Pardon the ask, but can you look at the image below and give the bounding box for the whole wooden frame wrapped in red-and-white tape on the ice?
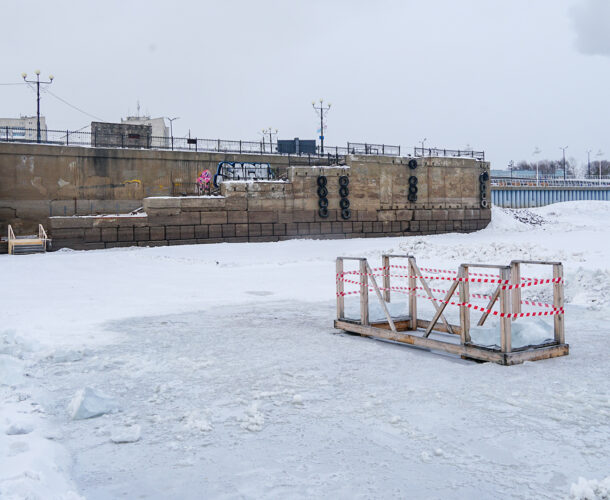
[334,255,569,365]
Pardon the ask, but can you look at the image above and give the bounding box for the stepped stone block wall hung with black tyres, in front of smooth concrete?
[49,157,491,249]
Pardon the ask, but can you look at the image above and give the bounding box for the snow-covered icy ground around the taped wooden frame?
[0,202,610,499]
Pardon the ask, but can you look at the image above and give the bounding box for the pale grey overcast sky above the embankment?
[0,0,610,168]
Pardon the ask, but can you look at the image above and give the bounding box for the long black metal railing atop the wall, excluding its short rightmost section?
[0,127,400,157]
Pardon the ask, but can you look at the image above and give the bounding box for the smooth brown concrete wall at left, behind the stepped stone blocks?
[0,142,308,234]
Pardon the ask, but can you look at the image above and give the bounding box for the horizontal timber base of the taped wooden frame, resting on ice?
[335,318,569,365]
